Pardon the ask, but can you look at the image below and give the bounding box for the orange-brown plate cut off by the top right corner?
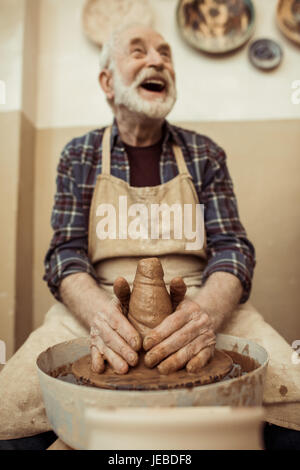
[276,0,300,45]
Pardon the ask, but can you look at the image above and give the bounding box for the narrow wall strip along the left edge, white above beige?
[0,0,25,358]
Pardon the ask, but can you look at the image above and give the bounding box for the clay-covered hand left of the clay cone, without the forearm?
[90,278,142,374]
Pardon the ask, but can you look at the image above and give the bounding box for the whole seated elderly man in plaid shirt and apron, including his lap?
[0,25,300,450]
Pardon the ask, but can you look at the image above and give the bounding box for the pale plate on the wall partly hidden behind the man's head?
[82,0,154,47]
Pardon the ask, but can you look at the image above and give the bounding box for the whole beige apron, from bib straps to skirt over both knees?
[0,126,300,439]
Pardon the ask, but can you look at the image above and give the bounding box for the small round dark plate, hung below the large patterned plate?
[249,39,283,70]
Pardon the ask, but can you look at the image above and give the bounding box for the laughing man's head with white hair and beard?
[108,28,176,121]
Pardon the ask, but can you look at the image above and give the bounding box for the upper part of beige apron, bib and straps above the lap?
[89,123,206,292]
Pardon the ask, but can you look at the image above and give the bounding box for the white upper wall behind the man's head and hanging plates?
[37,0,300,128]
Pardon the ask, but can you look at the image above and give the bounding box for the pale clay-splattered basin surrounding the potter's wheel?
[37,334,268,449]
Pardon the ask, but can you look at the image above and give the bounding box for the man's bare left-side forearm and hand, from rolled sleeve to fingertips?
[60,273,142,374]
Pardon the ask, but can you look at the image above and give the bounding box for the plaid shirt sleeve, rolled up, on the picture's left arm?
[44,144,97,300]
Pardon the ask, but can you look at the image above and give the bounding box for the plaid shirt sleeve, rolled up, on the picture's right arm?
[201,143,255,303]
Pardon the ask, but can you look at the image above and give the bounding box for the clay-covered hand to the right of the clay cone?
[143,297,216,374]
